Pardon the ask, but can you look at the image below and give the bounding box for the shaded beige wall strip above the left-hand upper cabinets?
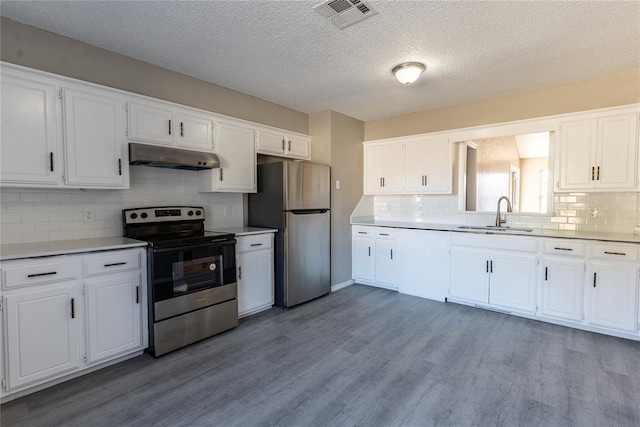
[0,18,309,134]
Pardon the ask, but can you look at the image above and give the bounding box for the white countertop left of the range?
[0,237,147,261]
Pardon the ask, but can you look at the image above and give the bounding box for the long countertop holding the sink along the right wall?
[351,220,640,243]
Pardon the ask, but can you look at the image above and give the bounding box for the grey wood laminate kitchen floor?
[0,285,640,427]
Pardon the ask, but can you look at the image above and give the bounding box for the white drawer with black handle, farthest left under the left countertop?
[2,258,78,289]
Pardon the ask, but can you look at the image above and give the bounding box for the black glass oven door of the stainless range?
[150,240,236,303]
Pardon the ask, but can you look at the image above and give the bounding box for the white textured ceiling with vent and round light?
[0,0,640,120]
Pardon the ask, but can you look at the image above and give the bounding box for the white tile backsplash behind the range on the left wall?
[0,166,243,244]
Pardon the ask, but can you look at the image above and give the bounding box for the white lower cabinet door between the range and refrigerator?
[238,251,273,316]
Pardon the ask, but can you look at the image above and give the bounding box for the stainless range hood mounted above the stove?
[129,142,220,171]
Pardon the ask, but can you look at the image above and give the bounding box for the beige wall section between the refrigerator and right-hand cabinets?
[309,111,364,286]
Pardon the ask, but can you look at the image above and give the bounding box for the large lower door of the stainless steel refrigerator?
[283,210,331,307]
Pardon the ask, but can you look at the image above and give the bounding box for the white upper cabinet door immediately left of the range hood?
[64,89,129,188]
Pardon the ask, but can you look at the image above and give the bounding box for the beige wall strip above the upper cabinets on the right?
[365,71,640,141]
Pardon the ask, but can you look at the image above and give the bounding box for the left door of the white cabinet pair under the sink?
[449,248,489,304]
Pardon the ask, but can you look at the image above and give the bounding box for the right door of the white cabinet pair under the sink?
[489,254,537,313]
